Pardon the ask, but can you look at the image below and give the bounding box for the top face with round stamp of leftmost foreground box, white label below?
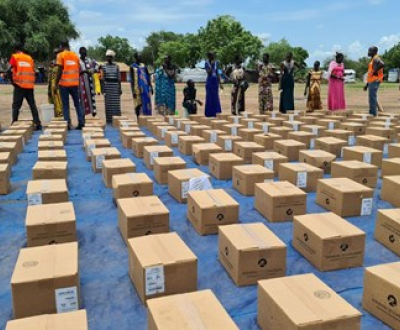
[11,242,78,284]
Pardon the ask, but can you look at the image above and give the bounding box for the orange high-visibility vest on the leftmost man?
[13,53,35,89]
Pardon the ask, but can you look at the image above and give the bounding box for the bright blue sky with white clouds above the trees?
[63,0,400,63]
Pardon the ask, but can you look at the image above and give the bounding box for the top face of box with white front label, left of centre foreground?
[129,232,197,268]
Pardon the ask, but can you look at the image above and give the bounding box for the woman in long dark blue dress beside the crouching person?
[204,52,223,117]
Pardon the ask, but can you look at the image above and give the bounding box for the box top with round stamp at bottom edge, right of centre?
[259,274,361,326]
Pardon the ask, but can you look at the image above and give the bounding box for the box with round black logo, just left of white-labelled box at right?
[254,181,307,222]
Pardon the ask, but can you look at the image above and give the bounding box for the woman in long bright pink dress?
[328,53,346,111]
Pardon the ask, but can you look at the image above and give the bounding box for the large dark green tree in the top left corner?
[0,0,79,61]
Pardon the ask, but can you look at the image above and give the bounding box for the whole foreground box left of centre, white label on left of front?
[128,233,198,304]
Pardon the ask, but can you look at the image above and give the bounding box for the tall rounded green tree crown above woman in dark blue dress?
[199,16,263,65]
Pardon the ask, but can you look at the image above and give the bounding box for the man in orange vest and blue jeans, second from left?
[54,41,85,130]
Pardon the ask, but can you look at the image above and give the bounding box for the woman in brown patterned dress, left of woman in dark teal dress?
[258,53,275,115]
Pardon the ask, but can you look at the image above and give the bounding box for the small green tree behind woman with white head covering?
[88,35,136,65]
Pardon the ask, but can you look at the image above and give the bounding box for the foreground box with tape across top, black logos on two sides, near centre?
[218,223,286,286]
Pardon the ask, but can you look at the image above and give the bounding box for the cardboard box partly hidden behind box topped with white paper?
[168,168,207,203]
